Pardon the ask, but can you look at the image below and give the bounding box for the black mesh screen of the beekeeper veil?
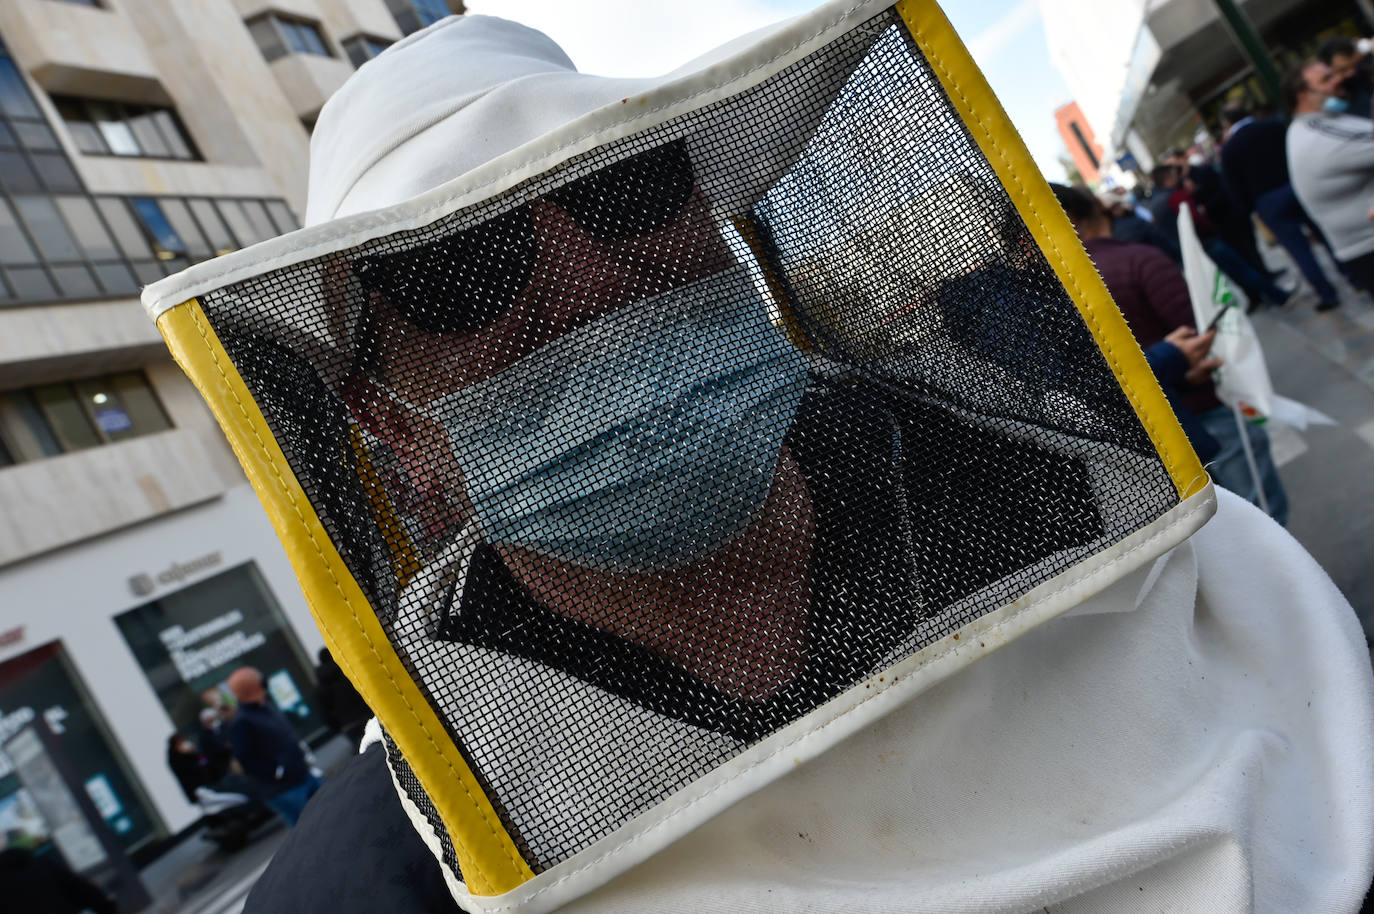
[203,8,1178,871]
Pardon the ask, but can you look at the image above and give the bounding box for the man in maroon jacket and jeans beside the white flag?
[1050,184,1287,524]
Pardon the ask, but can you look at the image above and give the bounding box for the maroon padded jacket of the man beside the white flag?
[1084,238,1221,423]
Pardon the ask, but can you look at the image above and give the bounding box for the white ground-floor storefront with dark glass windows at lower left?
[0,485,326,855]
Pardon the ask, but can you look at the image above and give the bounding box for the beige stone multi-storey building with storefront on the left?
[0,0,462,860]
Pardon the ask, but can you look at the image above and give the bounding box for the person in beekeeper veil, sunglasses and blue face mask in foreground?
[146,0,1374,914]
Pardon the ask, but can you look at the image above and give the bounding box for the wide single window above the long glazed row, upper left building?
[52,96,201,159]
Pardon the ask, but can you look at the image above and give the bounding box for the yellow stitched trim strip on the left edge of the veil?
[158,298,534,895]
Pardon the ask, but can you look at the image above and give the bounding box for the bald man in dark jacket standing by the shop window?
[229,667,322,826]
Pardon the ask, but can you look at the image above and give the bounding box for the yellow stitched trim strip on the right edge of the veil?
[896,0,1208,499]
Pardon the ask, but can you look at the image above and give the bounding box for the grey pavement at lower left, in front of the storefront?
[140,737,354,914]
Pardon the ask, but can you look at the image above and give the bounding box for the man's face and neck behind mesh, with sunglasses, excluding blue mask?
[339,142,812,698]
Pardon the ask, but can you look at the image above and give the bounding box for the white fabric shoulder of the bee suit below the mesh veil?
[563,491,1374,914]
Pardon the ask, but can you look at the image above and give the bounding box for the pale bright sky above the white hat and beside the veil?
[467,0,1069,180]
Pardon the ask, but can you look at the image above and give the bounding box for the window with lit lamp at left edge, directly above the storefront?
[0,371,172,463]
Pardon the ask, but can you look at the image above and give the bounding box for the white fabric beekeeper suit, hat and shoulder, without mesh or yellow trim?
[146,3,1374,914]
